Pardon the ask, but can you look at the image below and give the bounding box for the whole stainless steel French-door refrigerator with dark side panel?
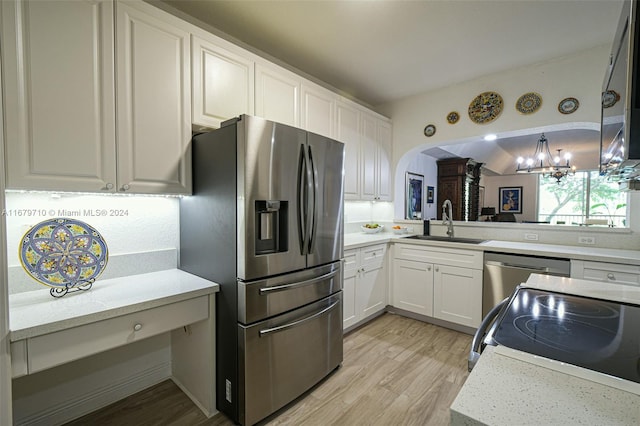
[180,115,344,424]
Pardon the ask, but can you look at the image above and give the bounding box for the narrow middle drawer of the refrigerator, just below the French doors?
[238,262,342,325]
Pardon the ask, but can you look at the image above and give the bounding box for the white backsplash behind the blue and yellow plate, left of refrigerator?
[4,191,179,294]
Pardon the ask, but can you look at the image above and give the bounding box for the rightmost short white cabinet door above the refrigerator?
[300,83,336,138]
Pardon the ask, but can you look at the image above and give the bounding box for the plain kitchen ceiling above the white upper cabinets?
[158,0,622,106]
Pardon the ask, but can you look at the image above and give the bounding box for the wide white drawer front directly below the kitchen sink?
[394,244,483,269]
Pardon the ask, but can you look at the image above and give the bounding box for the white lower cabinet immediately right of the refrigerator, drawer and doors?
[342,244,388,329]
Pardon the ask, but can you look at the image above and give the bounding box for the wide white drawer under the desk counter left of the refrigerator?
[27,296,209,374]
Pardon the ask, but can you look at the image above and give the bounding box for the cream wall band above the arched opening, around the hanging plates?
[379,46,610,164]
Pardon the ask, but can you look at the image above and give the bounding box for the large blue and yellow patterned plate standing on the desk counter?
[19,218,109,288]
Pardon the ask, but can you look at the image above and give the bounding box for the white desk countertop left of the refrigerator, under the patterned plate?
[9,269,219,341]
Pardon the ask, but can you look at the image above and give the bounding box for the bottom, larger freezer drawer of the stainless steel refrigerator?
[238,292,342,425]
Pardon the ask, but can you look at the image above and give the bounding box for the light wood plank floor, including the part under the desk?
[68,314,471,426]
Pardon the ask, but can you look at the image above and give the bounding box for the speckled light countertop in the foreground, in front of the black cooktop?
[450,346,640,426]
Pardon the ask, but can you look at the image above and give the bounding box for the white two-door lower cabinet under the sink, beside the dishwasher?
[392,244,483,327]
